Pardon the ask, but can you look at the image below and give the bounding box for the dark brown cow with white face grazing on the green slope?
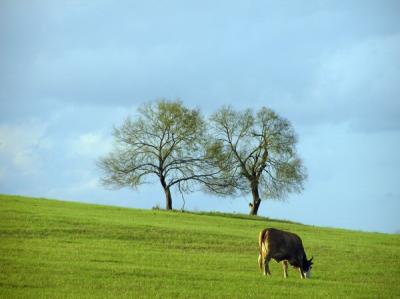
[258,228,313,278]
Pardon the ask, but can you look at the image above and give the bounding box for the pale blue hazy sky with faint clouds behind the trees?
[0,0,400,233]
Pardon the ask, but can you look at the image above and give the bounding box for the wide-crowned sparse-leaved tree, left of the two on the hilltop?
[98,100,222,210]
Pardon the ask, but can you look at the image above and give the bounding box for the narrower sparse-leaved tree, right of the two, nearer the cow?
[211,107,306,215]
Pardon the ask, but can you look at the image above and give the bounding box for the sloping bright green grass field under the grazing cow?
[0,195,400,298]
